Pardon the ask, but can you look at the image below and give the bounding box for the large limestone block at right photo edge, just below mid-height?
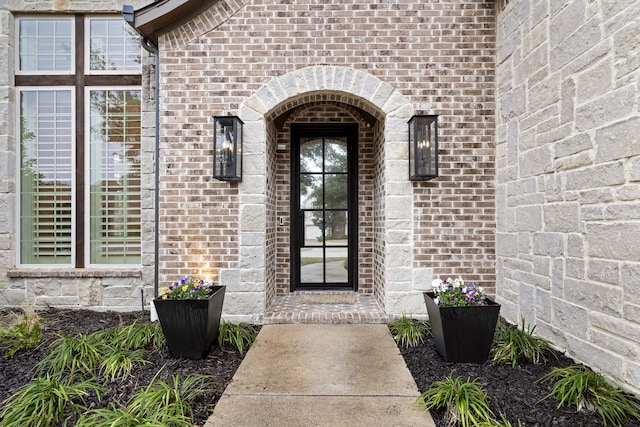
[586,222,640,261]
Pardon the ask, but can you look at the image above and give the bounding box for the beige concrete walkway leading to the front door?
[205,324,434,427]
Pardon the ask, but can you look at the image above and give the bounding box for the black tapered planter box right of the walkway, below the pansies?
[424,292,500,363]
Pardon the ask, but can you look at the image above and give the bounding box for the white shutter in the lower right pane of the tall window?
[89,89,141,264]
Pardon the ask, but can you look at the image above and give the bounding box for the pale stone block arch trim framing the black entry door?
[225,66,424,320]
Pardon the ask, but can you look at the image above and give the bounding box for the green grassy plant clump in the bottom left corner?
[0,375,103,427]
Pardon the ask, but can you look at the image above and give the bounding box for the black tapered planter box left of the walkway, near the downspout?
[153,286,226,359]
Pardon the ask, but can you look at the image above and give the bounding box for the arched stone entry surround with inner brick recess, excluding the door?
[235,66,413,322]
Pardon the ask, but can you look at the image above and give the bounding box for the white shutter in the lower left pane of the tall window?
[20,90,73,264]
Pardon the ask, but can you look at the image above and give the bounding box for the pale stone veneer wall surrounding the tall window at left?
[0,0,155,311]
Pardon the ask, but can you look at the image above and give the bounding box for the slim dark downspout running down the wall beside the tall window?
[122,5,160,300]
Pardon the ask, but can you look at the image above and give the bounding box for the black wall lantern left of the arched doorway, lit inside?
[213,116,244,181]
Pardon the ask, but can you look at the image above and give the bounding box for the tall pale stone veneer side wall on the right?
[496,0,640,393]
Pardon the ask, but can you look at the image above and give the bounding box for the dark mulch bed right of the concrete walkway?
[401,338,640,427]
